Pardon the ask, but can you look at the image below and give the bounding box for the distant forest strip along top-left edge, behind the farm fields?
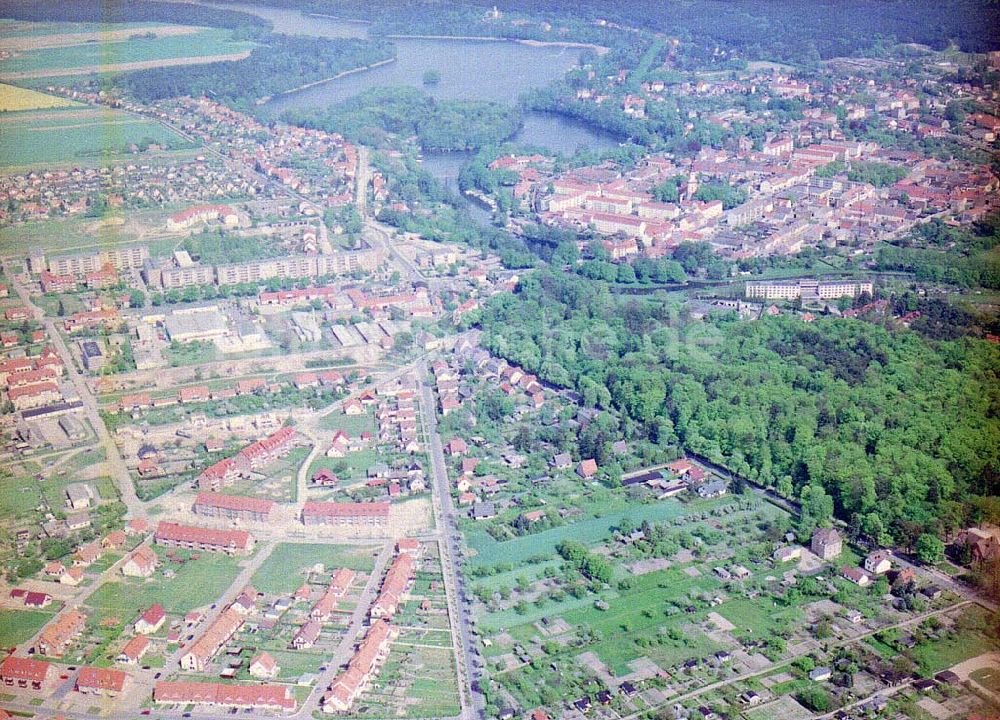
[0,0,271,30]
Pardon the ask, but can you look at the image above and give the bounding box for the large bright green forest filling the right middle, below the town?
[479,271,1000,542]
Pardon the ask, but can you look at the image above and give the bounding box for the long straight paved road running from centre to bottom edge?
[418,364,485,720]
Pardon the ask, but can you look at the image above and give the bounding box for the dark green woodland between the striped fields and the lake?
[124,33,395,109]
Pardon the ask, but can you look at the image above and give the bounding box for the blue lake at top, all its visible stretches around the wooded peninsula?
[205,3,618,221]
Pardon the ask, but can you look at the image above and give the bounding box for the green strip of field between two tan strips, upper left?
[0,29,253,75]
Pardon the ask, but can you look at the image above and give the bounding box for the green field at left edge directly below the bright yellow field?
[0,107,191,167]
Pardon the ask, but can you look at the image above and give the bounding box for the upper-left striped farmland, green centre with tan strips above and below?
[0,27,253,80]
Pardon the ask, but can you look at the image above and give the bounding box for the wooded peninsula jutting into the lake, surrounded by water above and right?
[282,87,521,150]
